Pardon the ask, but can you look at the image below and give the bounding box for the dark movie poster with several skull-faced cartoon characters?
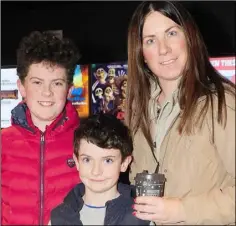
[91,62,127,120]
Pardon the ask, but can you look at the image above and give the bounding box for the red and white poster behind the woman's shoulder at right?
[210,56,235,84]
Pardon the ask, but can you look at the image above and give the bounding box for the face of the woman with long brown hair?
[142,11,187,83]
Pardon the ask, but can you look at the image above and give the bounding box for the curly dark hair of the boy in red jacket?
[17,31,80,84]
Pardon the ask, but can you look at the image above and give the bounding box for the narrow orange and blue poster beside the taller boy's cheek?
[68,65,89,118]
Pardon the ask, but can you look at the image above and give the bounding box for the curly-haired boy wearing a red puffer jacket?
[1,32,80,225]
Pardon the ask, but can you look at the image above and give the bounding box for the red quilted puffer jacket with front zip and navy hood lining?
[1,102,80,225]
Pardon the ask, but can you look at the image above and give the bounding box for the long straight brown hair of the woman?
[126,1,235,150]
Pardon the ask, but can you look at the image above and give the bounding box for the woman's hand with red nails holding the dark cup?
[133,196,186,224]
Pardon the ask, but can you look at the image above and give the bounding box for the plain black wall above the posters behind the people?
[1,1,235,65]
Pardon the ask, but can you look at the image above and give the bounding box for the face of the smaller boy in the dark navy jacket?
[74,139,131,193]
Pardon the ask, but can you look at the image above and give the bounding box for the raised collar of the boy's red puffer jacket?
[11,101,79,134]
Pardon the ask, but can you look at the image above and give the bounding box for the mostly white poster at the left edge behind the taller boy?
[1,68,22,128]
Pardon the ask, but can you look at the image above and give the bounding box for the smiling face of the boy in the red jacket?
[17,63,68,124]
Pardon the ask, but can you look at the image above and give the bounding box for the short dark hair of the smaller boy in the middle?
[74,113,133,161]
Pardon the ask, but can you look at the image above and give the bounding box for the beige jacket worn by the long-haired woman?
[130,89,235,225]
